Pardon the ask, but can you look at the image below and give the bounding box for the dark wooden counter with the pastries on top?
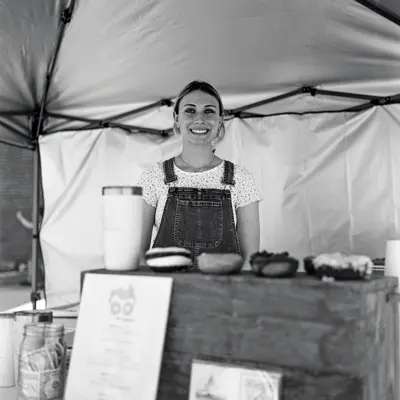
[82,270,399,400]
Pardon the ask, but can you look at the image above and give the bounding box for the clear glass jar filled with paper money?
[17,323,66,400]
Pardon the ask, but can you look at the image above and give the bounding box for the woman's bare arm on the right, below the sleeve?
[236,201,260,269]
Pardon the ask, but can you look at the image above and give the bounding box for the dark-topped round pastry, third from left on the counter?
[250,250,299,278]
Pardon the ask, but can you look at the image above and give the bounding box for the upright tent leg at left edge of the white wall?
[31,143,40,310]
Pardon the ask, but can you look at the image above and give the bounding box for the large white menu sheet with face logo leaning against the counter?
[65,274,172,400]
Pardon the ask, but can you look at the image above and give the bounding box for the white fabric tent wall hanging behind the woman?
[40,105,400,307]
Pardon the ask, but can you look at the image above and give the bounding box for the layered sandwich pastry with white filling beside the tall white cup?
[145,247,192,272]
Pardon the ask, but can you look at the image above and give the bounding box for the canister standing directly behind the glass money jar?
[13,310,53,385]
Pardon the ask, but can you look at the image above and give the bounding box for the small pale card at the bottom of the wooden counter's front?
[189,359,282,400]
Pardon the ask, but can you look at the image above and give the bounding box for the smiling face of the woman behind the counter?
[177,90,222,144]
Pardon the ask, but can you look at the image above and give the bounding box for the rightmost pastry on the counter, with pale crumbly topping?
[312,253,374,280]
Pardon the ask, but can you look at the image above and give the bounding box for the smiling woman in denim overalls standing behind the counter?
[139,81,261,268]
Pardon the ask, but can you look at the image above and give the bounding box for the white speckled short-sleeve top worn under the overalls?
[138,158,262,230]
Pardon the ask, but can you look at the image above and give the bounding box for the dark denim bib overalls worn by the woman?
[153,159,240,266]
